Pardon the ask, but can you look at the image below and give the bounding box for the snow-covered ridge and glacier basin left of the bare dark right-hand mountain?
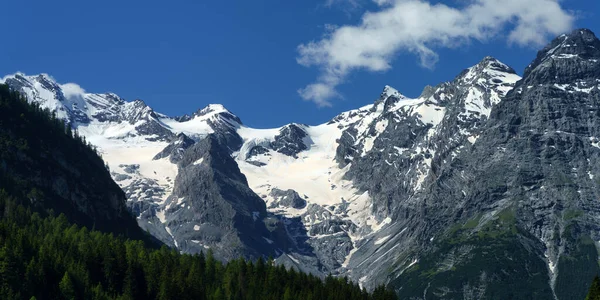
[3,57,519,276]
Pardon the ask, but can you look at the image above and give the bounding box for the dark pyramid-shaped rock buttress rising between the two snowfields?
[159,135,276,259]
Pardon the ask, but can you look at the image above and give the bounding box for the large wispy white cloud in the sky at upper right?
[297,0,574,105]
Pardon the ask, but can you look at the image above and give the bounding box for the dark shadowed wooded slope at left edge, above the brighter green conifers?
[0,85,146,238]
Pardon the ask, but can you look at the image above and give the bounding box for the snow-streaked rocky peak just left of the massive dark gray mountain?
[336,57,520,219]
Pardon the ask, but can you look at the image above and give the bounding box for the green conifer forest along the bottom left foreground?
[0,190,395,300]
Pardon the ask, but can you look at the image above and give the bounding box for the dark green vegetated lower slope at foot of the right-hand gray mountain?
[390,209,553,299]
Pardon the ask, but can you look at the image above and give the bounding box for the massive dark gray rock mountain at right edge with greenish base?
[378,30,600,299]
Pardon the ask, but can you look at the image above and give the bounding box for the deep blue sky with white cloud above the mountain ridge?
[0,0,600,127]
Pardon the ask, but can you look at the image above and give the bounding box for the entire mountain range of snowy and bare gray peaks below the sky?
[0,29,600,300]
